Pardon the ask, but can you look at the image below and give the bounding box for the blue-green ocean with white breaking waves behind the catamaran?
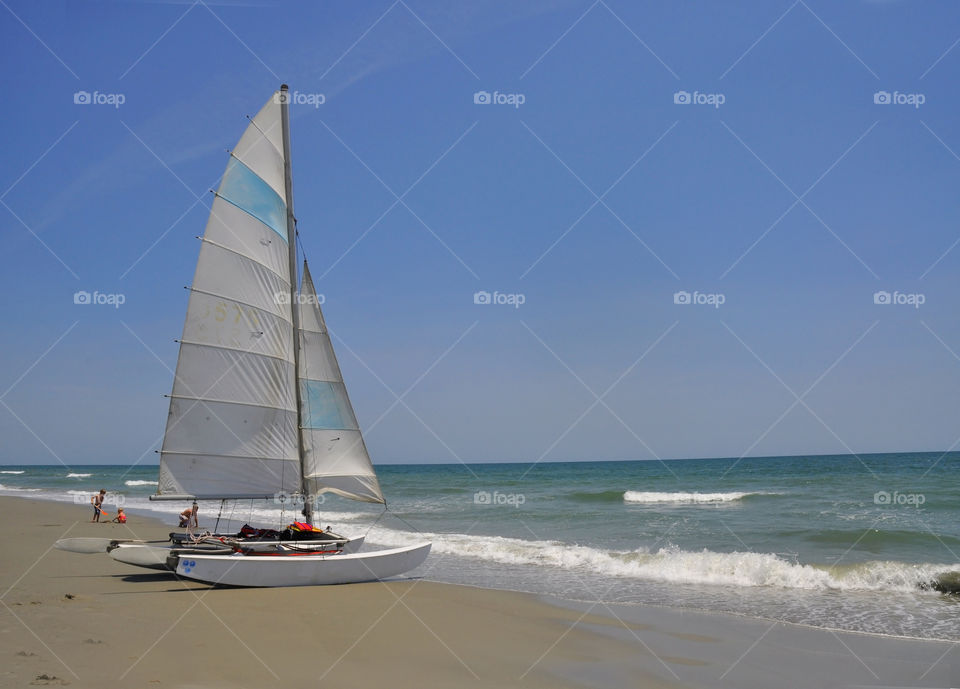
[0,453,960,640]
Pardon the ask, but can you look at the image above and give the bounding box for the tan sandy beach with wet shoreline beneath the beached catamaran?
[0,497,960,688]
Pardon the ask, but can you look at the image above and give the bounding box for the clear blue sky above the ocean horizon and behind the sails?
[0,0,960,464]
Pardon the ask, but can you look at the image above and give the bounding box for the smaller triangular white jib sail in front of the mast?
[297,262,384,503]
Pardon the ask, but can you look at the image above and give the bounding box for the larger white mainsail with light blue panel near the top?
[158,94,301,498]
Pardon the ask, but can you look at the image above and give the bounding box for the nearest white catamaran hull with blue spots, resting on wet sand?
[176,543,431,587]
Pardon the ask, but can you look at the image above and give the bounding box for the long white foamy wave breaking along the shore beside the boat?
[368,527,960,591]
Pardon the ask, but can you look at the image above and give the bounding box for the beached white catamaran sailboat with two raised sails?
[60,84,431,586]
